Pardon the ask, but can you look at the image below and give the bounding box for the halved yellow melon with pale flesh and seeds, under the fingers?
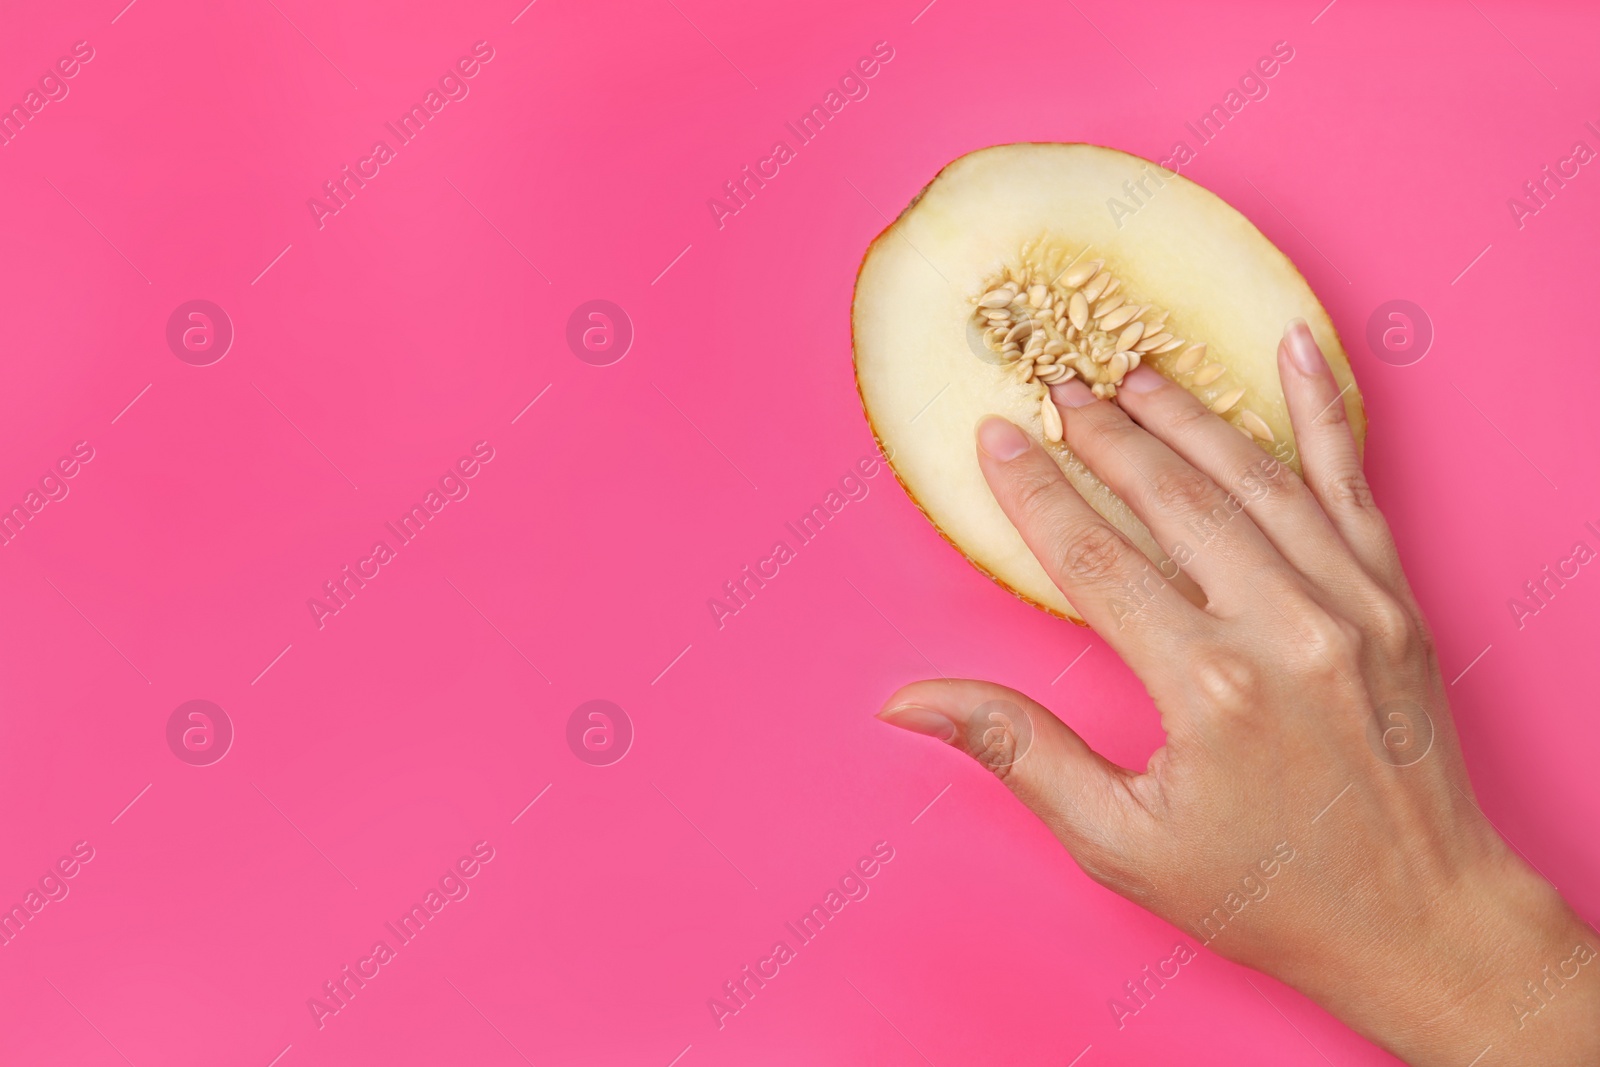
[851,144,1366,621]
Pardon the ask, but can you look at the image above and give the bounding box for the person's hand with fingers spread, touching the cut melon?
[880,320,1600,1067]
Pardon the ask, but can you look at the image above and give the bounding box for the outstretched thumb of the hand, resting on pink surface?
[878,678,1134,864]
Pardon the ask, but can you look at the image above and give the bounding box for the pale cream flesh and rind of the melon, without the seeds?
[851,144,1366,624]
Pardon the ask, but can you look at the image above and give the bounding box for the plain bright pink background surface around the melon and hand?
[0,0,1600,1067]
